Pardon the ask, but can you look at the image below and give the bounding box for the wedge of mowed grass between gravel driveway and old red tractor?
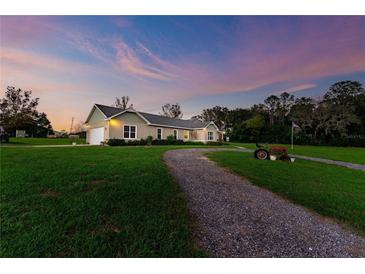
[209,152,365,233]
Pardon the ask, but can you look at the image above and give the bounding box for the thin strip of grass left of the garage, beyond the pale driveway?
[1,137,85,146]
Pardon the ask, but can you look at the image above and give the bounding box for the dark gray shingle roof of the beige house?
[95,104,210,128]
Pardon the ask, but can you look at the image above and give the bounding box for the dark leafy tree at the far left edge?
[0,87,39,135]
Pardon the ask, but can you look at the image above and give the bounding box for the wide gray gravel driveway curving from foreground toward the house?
[164,149,365,257]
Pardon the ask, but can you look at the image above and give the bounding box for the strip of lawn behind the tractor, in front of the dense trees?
[230,142,365,165]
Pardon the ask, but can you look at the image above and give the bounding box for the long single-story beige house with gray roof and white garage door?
[85,104,222,145]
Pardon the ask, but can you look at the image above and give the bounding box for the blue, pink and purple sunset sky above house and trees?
[0,16,365,130]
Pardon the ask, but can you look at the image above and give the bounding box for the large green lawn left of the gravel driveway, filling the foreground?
[0,147,205,257]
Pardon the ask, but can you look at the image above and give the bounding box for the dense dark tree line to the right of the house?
[195,81,365,146]
